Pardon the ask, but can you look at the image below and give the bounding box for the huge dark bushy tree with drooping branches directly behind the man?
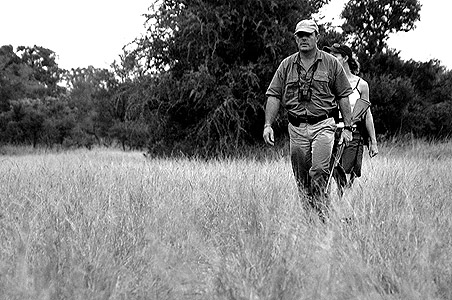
[129,0,328,155]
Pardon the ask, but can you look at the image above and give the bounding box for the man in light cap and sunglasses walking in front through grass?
[263,20,352,220]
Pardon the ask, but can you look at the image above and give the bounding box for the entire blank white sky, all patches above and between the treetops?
[0,0,452,70]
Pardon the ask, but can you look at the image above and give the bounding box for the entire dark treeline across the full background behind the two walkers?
[0,0,452,155]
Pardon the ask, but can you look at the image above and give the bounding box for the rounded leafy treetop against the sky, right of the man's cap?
[341,0,421,57]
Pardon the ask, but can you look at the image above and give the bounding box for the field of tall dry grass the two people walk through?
[0,142,452,300]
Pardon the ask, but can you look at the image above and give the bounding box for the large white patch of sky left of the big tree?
[0,0,150,70]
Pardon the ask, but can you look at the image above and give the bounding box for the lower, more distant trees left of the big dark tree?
[0,45,150,149]
